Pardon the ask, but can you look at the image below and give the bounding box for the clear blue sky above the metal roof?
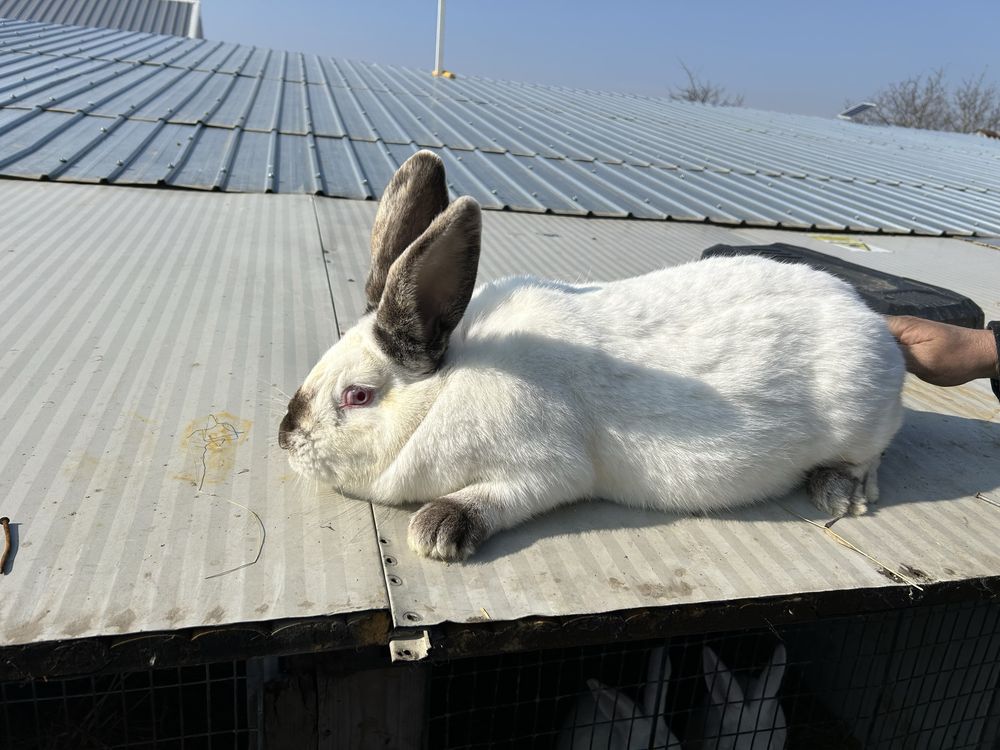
[201,0,1000,115]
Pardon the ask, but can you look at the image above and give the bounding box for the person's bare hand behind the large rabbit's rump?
[885,315,997,385]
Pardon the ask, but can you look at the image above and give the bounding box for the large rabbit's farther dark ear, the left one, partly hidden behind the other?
[365,151,448,312]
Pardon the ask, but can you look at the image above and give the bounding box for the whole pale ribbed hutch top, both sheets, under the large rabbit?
[0,181,1000,645]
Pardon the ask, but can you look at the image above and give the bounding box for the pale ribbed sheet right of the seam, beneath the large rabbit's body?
[364,225,1000,625]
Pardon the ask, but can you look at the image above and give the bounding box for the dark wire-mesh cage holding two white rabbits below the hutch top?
[427,601,1000,750]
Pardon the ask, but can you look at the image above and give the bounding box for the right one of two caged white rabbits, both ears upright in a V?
[688,643,788,750]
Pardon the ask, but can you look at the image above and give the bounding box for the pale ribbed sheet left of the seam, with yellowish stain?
[0,180,387,645]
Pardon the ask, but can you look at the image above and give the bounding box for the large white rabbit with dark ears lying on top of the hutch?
[279,151,904,560]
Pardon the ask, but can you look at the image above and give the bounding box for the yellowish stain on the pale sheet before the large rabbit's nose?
[174,411,253,490]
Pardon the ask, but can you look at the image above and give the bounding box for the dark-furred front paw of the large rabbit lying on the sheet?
[407,500,487,562]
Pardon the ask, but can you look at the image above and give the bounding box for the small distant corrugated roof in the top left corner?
[0,0,201,39]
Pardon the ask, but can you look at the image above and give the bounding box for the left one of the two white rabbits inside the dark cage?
[558,647,681,750]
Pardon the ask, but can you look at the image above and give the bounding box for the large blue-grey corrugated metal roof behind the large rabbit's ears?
[0,17,1000,235]
